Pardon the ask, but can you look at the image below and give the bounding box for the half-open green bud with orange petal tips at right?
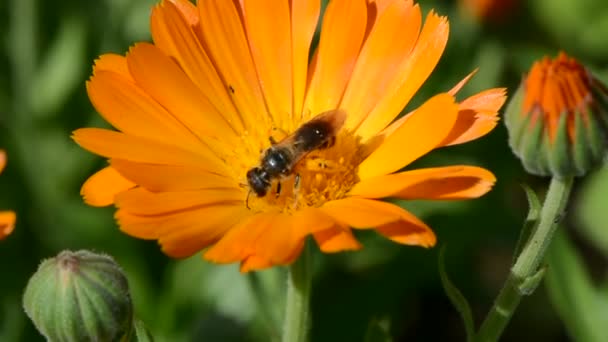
[505,52,608,178]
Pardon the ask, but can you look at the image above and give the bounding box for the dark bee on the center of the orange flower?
[247,109,346,200]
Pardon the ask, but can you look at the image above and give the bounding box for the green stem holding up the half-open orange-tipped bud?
[475,177,574,342]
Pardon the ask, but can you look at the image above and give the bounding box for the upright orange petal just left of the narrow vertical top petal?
[244,0,293,127]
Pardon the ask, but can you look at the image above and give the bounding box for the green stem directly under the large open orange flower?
[282,243,312,342]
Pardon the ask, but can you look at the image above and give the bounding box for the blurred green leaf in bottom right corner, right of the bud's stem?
[546,229,608,342]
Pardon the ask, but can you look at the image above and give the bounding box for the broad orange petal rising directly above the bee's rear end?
[304,0,367,117]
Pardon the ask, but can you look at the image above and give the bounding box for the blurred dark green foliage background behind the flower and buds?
[0,0,608,341]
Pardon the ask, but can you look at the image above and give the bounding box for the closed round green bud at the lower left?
[23,251,133,341]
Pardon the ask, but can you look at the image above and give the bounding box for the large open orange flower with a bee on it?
[74,0,505,271]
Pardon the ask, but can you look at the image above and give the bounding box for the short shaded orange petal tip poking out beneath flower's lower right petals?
[376,215,437,247]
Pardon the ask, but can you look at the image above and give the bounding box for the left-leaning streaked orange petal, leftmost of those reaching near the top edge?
[151,2,244,132]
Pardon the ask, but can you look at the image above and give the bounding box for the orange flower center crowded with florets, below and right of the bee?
[246,131,362,213]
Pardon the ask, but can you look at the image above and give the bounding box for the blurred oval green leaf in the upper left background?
[29,17,87,117]
